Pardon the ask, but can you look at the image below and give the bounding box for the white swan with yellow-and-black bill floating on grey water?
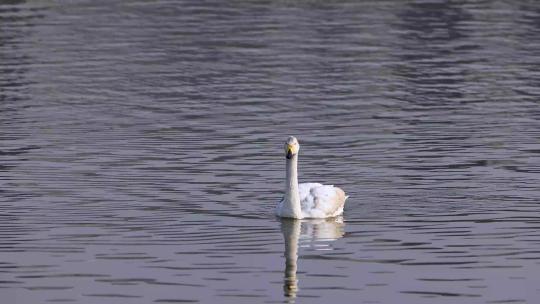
[276,136,348,219]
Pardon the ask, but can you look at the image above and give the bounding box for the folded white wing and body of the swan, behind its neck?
[298,183,347,218]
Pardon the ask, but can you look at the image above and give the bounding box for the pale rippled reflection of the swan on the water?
[281,217,345,298]
